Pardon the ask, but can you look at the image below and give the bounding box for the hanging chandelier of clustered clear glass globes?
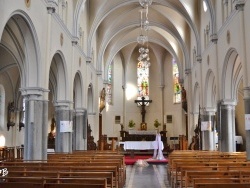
[137,0,152,68]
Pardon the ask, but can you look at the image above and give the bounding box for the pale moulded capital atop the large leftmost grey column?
[19,87,49,100]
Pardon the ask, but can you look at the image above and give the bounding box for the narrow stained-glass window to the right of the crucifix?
[172,59,181,103]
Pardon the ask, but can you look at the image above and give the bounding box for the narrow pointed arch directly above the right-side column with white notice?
[204,69,216,108]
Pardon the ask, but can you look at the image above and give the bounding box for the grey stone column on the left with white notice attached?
[55,101,73,153]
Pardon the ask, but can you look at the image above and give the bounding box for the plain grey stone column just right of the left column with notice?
[73,109,87,150]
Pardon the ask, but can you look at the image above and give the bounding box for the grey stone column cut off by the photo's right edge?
[244,87,250,161]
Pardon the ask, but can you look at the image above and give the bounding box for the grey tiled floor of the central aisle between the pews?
[124,164,170,188]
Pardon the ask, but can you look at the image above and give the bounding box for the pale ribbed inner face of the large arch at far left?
[5,10,42,87]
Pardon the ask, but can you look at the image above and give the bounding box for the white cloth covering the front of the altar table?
[123,141,164,150]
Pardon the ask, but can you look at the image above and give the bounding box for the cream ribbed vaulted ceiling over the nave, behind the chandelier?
[85,0,210,80]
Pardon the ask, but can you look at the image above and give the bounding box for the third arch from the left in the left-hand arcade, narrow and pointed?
[74,72,84,109]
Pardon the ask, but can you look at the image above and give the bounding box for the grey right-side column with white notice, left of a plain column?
[202,108,215,151]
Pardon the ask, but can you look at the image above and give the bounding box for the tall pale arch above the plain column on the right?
[221,48,243,100]
